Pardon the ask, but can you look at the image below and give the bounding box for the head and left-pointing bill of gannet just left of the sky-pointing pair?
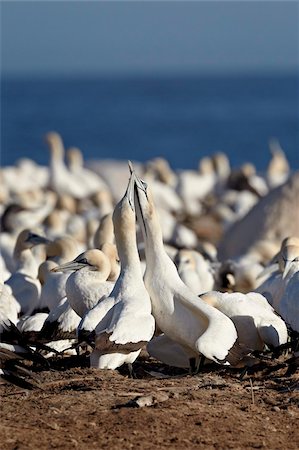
[52,249,111,280]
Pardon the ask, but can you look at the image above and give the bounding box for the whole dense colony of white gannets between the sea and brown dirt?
[0,132,299,383]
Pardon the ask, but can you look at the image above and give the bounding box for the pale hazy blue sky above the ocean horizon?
[1,1,299,75]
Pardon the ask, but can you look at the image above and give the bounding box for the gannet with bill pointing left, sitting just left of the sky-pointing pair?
[53,249,114,317]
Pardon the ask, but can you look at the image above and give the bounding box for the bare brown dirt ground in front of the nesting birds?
[0,357,299,450]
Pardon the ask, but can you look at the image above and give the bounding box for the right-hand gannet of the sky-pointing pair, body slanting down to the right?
[135,169,244,364]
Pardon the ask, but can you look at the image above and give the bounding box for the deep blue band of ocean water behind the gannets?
[1,74,299,170]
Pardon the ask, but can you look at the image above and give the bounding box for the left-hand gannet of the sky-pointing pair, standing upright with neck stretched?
[90,169,155,369]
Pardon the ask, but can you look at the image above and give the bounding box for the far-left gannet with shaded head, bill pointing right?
[6,230,49,315]
